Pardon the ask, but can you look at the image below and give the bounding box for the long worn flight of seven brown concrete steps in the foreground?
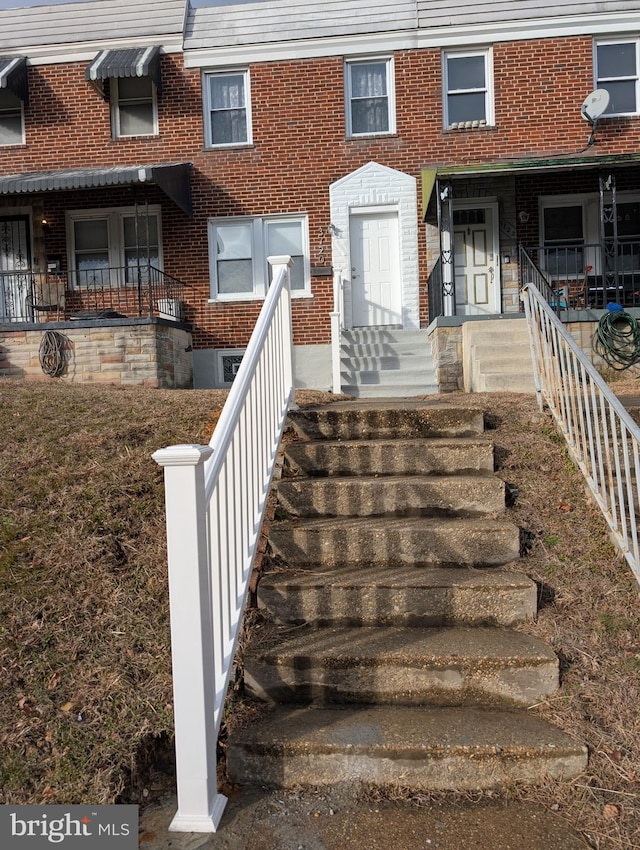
[227,401,587,790]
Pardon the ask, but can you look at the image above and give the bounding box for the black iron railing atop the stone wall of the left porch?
[0,265,186,324]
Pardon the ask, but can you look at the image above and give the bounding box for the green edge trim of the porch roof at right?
[421,152,640,218]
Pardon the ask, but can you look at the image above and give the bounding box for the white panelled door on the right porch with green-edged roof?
[453,207,500,316]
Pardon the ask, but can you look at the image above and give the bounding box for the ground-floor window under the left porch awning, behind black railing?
[67,205,162,286]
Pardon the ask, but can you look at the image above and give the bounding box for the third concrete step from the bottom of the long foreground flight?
[258,565,538,627]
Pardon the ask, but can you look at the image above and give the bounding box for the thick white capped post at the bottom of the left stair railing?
[153,445,227,832]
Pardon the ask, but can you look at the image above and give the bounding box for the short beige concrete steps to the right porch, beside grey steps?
[462,319,535,393]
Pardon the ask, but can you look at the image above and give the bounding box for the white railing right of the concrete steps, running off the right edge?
[522,265,640,582]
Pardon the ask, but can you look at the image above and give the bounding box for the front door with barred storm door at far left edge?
[0,216,31,322]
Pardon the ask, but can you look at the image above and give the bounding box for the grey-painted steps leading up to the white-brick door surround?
[340,327,438,398]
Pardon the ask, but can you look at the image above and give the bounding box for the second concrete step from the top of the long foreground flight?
[285,438,494,476]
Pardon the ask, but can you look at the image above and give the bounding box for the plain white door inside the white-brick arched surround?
[349,212,402,328]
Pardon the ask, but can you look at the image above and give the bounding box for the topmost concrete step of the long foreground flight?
[288,401,484,440]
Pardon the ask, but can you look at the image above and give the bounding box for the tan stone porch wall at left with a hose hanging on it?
[0,319,193,389]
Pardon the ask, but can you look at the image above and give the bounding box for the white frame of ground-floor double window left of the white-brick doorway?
[208,214,311,302]
